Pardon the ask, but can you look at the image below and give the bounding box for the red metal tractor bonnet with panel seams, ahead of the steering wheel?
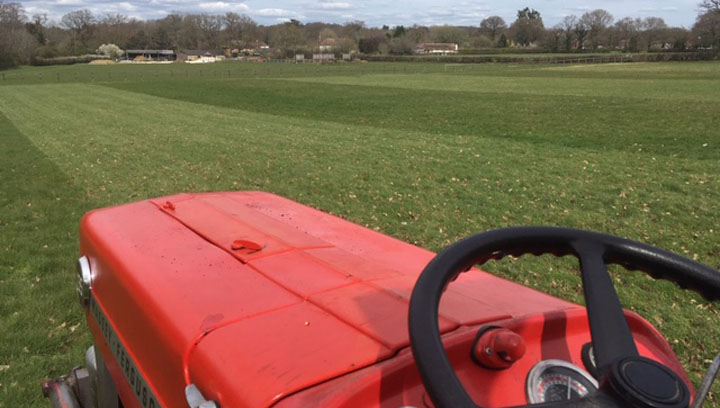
[81,192,576,407]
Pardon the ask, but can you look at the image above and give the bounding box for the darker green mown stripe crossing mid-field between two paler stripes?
[107,80,720,160]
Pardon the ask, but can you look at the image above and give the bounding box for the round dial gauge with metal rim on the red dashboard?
[527,360,598,404]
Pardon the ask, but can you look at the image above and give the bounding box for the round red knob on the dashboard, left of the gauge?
[473,328,525,369]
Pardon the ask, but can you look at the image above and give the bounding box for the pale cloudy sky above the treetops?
[18,0,700,28]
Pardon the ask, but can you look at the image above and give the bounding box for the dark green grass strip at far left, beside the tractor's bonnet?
[0,111,93,407]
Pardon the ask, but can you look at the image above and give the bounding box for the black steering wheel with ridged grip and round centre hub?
[408,227,720,408]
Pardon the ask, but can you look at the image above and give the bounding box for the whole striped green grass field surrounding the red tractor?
[0,62,720,407]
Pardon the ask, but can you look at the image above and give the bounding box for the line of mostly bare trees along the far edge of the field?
[0,0,720,68]
